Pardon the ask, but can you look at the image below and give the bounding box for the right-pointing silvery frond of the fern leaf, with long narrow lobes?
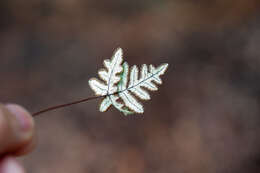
[118,62,168,113]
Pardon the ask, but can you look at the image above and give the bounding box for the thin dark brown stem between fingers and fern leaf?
[32,95,104,117]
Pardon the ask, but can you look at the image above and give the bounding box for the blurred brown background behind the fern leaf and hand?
[0,0,260,173]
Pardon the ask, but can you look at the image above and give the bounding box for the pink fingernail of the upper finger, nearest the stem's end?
[6,104,33,132]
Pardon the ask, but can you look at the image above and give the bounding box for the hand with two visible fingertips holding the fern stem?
[0,104,34,173]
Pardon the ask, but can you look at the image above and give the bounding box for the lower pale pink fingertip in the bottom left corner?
[0,158,24,173]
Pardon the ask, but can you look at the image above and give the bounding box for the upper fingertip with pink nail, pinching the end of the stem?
[0,104,34,155]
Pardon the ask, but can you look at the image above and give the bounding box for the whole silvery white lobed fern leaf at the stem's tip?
[89,48,168,115]
